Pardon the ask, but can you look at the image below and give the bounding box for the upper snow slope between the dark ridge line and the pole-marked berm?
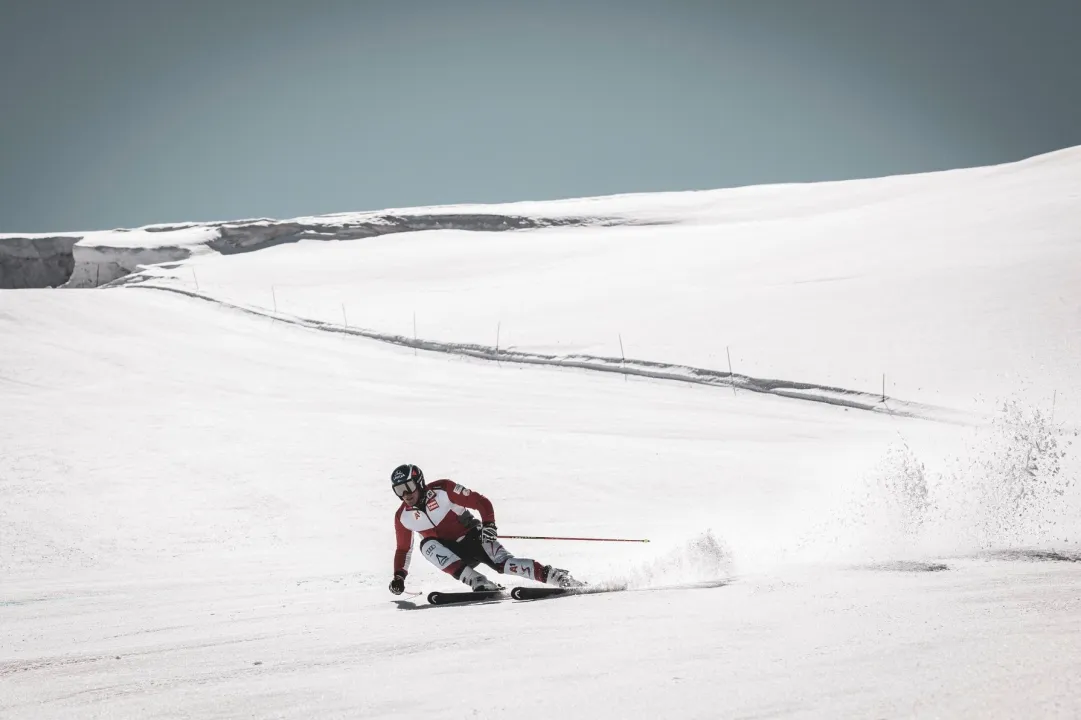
[118,149,1081,418]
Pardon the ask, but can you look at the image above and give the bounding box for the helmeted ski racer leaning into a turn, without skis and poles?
[390,465,582,595]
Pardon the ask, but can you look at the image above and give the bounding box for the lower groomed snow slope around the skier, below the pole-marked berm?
[0,291,1081,718]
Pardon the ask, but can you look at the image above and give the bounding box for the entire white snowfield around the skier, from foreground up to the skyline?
[0,144,1081,719]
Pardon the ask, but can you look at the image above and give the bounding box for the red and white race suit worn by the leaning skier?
[395,480,547,583]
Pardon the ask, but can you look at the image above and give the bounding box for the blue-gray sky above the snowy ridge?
[0,0,1081,232]
